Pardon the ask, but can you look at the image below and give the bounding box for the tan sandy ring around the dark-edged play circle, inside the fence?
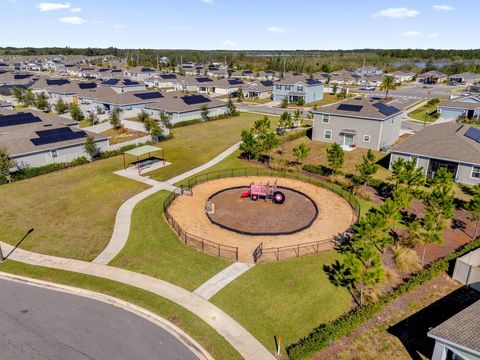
[169,176,355,263]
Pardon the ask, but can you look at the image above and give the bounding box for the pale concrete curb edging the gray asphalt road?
[0,271,214,360]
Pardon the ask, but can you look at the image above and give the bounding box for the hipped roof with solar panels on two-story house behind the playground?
[316,97,402,120]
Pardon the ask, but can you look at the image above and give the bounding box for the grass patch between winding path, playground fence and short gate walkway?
[110,191,232,290]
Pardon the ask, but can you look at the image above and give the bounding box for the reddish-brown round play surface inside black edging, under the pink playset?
[207,186,318,236]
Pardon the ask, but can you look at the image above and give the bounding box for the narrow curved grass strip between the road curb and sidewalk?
[0,260,242,359]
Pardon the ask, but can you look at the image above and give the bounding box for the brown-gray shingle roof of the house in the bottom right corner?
[428,300,480,354]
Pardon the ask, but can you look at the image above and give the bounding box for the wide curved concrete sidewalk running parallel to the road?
[0,242,275,360]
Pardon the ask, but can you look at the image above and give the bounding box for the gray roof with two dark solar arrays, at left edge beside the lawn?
[0,109,106,156]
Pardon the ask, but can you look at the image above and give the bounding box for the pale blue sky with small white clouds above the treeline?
[0,0,480,49]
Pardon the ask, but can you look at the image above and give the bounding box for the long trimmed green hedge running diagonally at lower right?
[286,238,480,359]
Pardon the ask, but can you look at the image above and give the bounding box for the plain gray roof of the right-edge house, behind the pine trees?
[392,122,480,164]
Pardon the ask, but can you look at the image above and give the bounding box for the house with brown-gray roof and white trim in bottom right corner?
[427,300,480,360]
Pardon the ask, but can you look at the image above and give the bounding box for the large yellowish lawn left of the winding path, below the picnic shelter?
[0,157,148,260]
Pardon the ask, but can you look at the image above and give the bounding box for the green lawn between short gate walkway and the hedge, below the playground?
[211,251,351,350]
